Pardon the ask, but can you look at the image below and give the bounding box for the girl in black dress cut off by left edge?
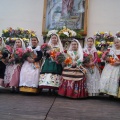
[0,37,8,86]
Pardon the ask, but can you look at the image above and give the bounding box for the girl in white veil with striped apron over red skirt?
[58,39,88,98]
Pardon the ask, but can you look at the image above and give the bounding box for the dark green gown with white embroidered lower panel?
[39,46,63,89]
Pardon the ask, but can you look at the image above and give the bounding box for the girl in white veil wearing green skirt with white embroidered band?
[39,34,63,93]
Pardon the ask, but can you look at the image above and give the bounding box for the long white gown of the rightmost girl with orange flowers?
[100,49,120,97]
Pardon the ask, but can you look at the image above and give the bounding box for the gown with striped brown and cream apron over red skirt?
[58,51,88,98]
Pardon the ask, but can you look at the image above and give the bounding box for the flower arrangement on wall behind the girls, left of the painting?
[2,27,36,46]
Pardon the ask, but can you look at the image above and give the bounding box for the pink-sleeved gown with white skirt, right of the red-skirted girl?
[84,48,100,96]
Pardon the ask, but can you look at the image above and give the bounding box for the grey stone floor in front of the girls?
[0,89,120,120]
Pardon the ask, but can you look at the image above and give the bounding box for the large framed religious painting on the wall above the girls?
[43,0,88,32]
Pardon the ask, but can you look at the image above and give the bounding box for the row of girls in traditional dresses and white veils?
[0,34,120,98]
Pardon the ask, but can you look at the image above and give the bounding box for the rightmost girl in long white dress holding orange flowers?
[100,38,120,97]
